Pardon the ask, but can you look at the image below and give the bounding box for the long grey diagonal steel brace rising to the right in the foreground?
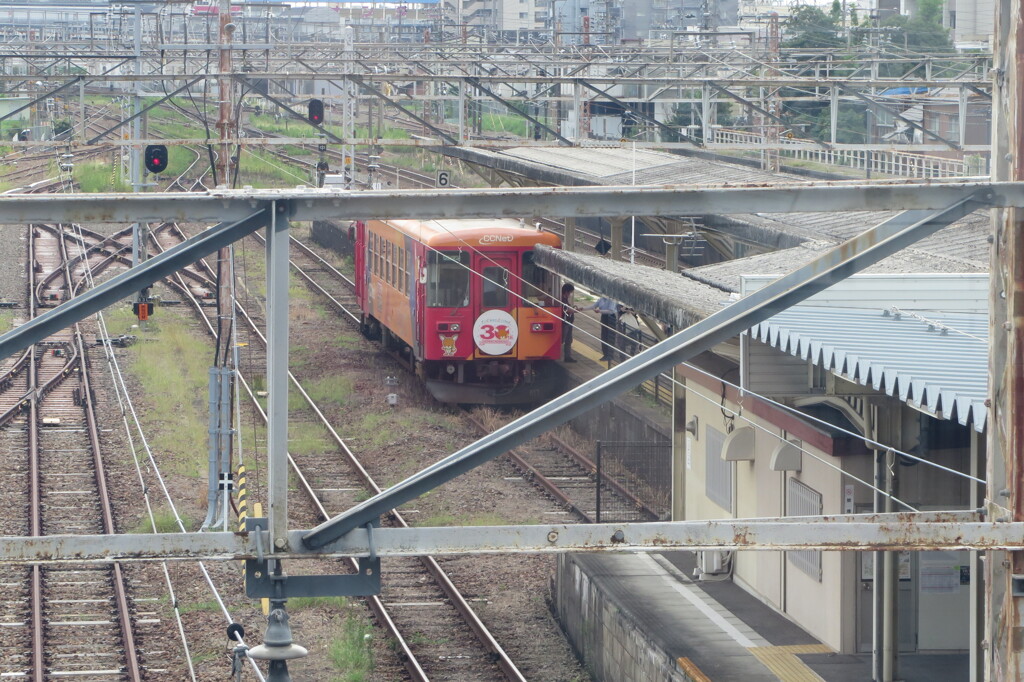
[303,196,981,548]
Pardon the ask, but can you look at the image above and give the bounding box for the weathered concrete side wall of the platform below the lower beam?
[552,554,690,682]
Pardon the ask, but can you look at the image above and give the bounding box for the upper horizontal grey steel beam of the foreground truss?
[0,180,1011,224]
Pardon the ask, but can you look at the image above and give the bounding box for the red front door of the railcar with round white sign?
[473,254,519,357]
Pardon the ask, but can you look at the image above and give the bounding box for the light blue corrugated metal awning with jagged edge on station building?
[751,305,988,431]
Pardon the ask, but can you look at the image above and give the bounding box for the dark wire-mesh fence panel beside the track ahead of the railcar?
[595,440,672,523]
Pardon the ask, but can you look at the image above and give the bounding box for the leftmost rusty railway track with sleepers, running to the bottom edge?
[0,226,166,680]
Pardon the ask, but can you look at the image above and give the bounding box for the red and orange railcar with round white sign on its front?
[355,219,562,404]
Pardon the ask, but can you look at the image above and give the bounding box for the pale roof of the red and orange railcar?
[383,218,562,249]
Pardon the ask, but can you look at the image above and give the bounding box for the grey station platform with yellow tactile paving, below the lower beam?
[554,552,969,682]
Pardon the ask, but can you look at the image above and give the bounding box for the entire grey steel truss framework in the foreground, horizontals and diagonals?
[0,182,1024,679]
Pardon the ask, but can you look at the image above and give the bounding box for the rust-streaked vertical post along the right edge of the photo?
[987,0,1024,682]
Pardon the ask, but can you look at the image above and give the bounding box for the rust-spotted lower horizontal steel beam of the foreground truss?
[0,512,1024,563]
